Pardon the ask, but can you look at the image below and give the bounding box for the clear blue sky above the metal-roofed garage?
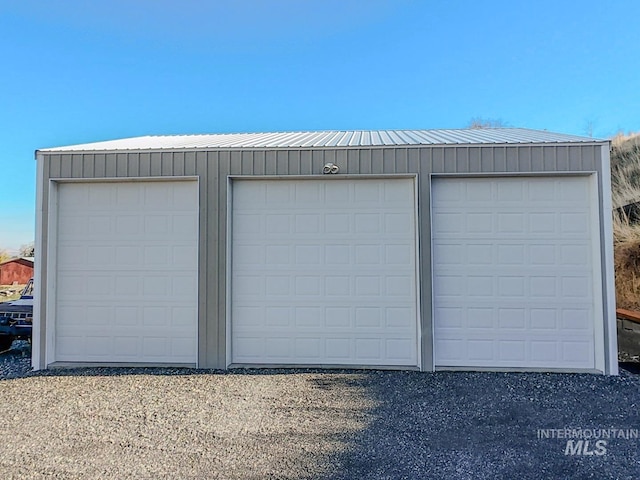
[0,0,640,249]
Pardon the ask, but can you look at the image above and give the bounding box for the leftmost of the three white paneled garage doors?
[54,181,198,364]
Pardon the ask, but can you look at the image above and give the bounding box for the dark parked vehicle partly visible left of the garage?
[0,279,33,352]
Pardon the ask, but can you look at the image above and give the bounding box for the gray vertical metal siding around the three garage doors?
[39,143,605,370]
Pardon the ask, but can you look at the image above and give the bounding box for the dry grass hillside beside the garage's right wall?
[611,133,640,311]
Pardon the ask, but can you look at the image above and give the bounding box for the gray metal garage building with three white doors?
[33,128,617,374]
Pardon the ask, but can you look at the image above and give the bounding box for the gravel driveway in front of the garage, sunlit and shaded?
[0,349,640,479]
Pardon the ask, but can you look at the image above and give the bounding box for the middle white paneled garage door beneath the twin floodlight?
[231,179,418,366]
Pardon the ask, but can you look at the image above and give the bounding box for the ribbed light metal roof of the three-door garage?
[38,128,602,153]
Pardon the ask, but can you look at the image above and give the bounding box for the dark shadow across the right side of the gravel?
[322,370,640,479]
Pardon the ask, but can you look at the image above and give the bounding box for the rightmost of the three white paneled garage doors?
[432,177,603,369]
